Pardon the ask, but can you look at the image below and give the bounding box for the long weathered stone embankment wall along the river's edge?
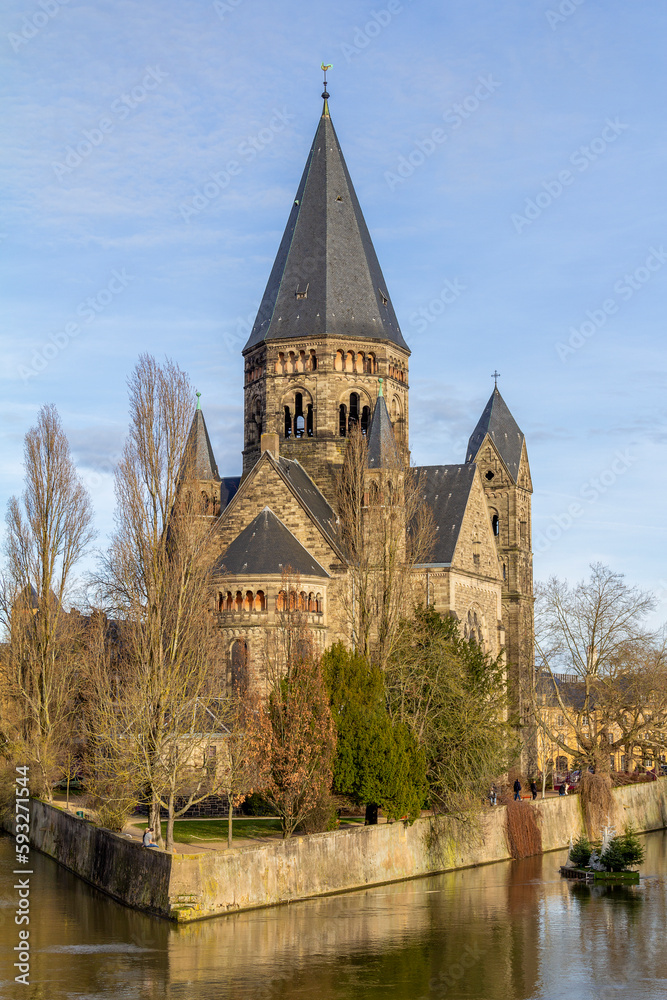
[9,779,667,922]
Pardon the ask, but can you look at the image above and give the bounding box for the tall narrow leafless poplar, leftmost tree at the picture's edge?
[0,406,94,799]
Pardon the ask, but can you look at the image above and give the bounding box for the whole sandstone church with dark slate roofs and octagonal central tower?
[184,90,533,728]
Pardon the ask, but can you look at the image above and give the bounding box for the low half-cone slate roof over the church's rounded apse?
[215,507,329,577]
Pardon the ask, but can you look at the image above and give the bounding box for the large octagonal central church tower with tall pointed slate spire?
[243,81,410,502]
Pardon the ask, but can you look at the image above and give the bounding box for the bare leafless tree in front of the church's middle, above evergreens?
[337,427,434,668]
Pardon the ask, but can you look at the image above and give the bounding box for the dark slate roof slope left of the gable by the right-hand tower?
[414,463,477,565]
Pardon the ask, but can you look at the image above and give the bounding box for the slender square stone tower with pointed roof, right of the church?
[466,385,534,769]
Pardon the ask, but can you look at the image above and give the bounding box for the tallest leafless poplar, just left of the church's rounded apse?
[92,355,230,850]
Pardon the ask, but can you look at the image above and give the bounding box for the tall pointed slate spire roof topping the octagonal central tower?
[244,105,407,352]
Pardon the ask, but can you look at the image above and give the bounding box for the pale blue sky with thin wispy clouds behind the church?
[0,0,667,618]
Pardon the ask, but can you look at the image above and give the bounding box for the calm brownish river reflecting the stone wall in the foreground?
[0,832,667,1000]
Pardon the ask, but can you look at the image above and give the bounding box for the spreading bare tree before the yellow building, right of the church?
[535,563,667,774]
